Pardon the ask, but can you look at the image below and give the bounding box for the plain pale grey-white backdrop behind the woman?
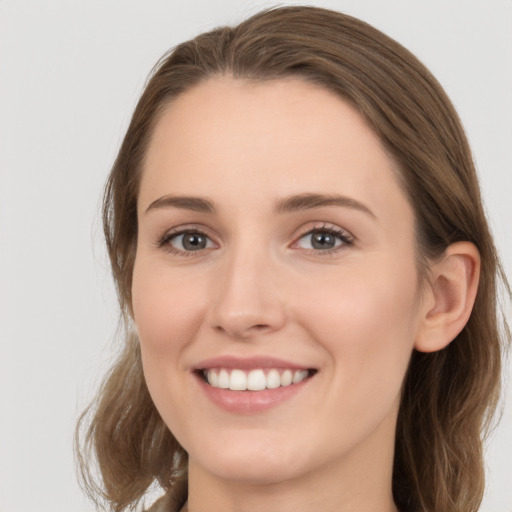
[0,0,512,512]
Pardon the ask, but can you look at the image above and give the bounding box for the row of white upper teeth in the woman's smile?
[204,368,309,391]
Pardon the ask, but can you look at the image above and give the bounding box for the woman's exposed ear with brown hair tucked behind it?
[414,242,480,352]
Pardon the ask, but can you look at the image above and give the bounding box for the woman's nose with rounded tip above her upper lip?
[210,248,286,339]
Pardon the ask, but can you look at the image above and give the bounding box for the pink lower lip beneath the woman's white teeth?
[196,375,312,414]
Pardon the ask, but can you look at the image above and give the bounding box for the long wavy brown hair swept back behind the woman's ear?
[77,7,510,512]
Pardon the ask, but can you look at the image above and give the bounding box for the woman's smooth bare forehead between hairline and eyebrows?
[139,77,405,224]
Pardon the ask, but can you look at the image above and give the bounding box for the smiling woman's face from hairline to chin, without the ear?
[132,77,421,483]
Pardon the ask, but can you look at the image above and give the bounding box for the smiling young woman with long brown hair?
[75,7,506,512]
